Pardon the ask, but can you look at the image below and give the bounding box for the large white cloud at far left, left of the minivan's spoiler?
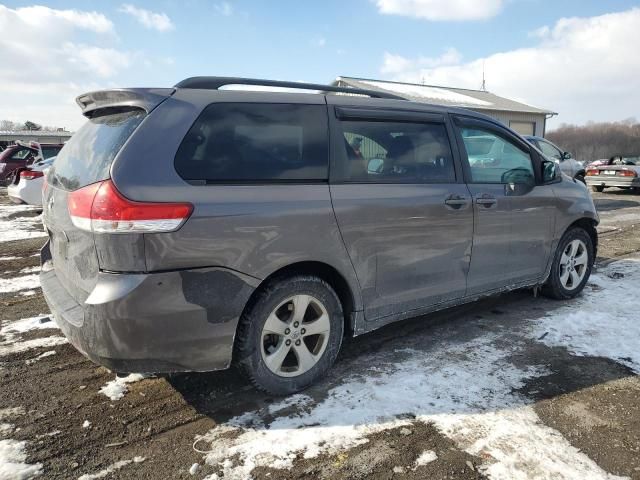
[0,5,134,129]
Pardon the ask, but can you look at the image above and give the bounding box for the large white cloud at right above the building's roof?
[380,8,640,123]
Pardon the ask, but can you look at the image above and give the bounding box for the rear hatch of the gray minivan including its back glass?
[43,108,146,302]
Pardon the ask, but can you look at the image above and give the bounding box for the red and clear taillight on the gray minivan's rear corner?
[68,180,193,233]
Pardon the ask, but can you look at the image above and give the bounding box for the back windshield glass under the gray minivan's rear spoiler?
[49,110,145,190]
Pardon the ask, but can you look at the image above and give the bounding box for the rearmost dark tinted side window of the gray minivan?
[175,103,328,182]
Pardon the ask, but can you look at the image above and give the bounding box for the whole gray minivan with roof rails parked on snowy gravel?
[41,77,598,394]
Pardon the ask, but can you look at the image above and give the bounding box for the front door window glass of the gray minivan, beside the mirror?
[460,128,535,183]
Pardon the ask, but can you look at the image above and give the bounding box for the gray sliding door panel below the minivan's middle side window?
[331,184,473,320]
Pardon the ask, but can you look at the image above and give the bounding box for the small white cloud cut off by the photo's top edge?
[376,0,504,21]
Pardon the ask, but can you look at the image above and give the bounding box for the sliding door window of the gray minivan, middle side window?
[341,121,455,183]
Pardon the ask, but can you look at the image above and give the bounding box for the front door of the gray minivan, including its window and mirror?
[457,120,556,295]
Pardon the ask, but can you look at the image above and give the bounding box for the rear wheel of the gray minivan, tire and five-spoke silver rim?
[234,275,344,395]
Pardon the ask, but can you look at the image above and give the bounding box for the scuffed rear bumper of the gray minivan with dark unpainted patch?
[40,242,257,373]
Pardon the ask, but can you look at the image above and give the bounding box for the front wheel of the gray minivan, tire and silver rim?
[542,227,594,300]
